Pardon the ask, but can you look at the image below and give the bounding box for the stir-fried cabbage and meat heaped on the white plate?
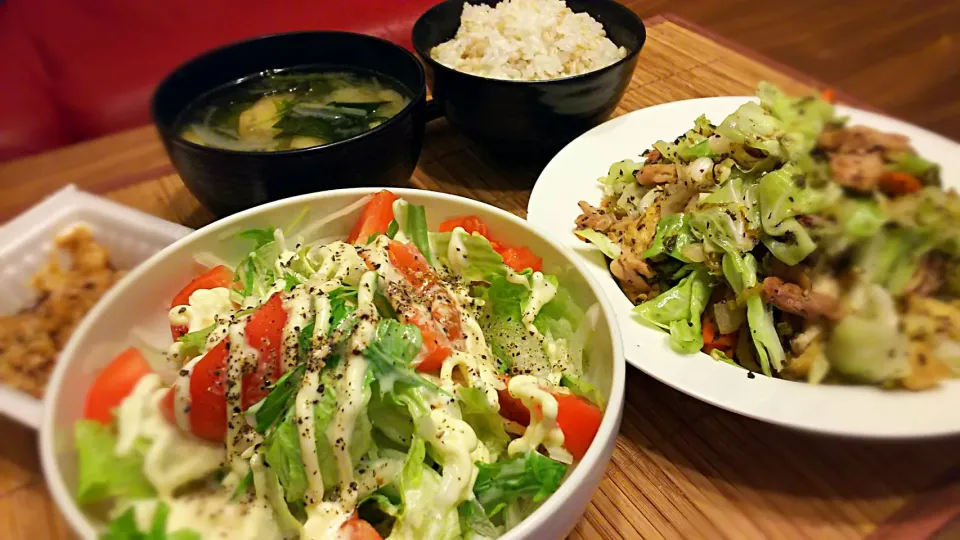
[576,83,960,390]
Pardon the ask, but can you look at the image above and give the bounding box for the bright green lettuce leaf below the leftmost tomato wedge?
[73,420,155,505]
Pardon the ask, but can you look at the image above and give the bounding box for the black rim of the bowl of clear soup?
[150,30,427,158]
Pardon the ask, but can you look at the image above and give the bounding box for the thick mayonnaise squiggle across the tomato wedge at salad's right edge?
[507,375,573,463]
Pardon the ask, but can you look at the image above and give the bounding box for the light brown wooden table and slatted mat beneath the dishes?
[0,17,960,539]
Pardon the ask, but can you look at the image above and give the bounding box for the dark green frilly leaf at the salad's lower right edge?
[473,451,567,517]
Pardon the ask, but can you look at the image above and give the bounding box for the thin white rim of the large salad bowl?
[40,187,626,540]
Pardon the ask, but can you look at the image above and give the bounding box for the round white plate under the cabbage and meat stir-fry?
[527,97,960,439]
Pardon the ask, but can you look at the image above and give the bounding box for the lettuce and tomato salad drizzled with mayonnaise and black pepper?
[74,191,604,540]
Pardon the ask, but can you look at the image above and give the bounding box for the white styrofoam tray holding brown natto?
[0,185,192,429]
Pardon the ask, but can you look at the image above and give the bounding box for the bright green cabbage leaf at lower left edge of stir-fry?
[633,265,713,354]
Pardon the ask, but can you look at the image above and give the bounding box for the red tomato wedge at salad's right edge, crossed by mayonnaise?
[497,380,603,460]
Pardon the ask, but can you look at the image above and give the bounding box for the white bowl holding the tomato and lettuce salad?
[40,189,625,540]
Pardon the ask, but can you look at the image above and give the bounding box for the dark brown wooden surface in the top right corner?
[620,0,960,140]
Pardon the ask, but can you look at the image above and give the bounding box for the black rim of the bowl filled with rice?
[410,0,647,88]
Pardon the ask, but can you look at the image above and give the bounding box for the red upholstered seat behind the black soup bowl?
[0,0,439,160]
